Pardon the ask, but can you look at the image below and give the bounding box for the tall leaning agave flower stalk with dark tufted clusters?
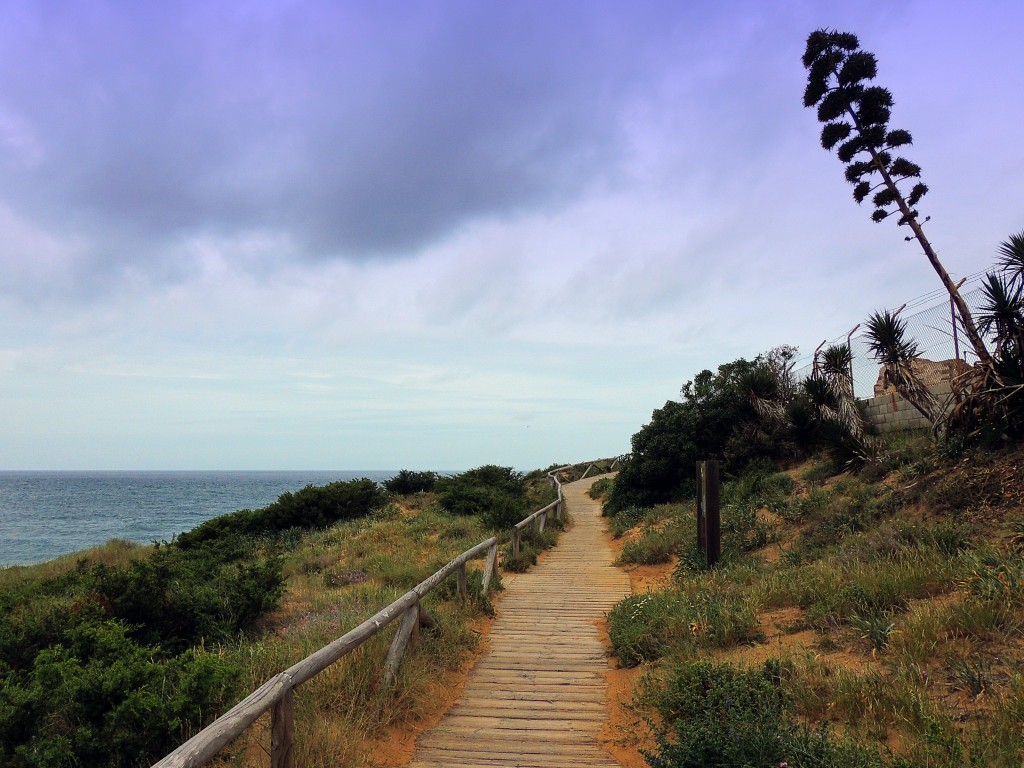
[803,30,994,371]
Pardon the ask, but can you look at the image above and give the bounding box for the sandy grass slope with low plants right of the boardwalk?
[609,442,1024,768]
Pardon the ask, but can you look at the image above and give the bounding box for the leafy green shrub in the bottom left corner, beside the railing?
[0,621,241,768]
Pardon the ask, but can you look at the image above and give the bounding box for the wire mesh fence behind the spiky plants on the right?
[794,275,983,398]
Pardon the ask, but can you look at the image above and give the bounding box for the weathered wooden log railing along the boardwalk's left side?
[152,459,618,768]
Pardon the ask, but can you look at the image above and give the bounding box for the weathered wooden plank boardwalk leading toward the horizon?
[411,477,630,768]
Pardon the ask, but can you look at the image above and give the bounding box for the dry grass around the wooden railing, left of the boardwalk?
[195,499,500,768]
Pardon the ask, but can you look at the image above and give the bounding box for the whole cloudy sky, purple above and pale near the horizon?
[0,0,1024,470]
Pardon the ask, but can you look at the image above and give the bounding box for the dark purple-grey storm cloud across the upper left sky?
[0,2,679,258]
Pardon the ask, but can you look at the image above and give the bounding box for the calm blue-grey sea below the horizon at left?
[0,471,394,565]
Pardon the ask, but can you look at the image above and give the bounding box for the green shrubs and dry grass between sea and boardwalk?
[0,467,555,768]
